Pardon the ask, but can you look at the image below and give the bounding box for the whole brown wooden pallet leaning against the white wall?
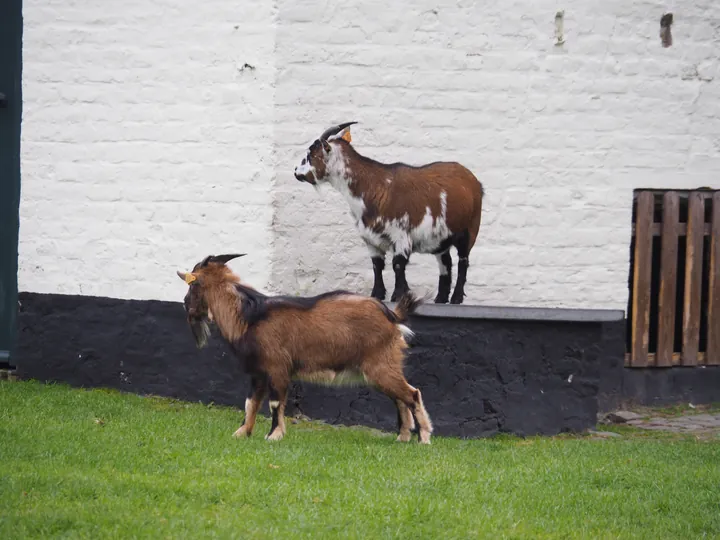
[625,190,720,367]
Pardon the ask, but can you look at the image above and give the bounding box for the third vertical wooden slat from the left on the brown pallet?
[682,192,705,366]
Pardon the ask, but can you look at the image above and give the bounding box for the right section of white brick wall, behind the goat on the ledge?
[272,0,720,309]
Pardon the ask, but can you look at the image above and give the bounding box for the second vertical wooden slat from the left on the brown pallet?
[656,191,680,367]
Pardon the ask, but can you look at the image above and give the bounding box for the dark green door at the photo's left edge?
[0,0,22,364]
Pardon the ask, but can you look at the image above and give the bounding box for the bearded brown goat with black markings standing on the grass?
[178,255,432,443]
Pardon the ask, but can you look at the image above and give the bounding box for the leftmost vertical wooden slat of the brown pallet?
[630,191,654,367]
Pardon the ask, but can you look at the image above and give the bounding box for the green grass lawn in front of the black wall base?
[0,382,720,539]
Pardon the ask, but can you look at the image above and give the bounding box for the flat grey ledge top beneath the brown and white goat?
[386,302,625,322]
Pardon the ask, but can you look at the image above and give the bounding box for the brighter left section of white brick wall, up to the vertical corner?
[19,0,275,300]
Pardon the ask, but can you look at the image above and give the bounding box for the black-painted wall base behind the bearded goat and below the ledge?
[14,293,624,437]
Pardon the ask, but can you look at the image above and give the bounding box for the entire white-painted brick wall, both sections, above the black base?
[20,0,720,309]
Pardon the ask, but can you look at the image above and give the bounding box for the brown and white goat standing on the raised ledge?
[295,122,484,304]
